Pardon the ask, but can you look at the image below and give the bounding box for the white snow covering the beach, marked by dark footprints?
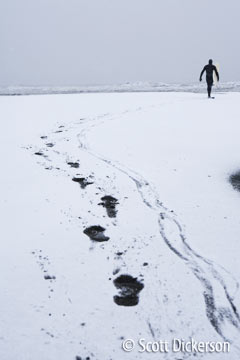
[0,93,240,360]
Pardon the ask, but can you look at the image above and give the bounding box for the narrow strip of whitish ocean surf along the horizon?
[0,81,240,95]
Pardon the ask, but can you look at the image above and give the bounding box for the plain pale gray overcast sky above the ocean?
[0,0,240,86]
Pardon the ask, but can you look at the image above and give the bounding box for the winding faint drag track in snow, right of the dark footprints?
[31,105,239,346]
